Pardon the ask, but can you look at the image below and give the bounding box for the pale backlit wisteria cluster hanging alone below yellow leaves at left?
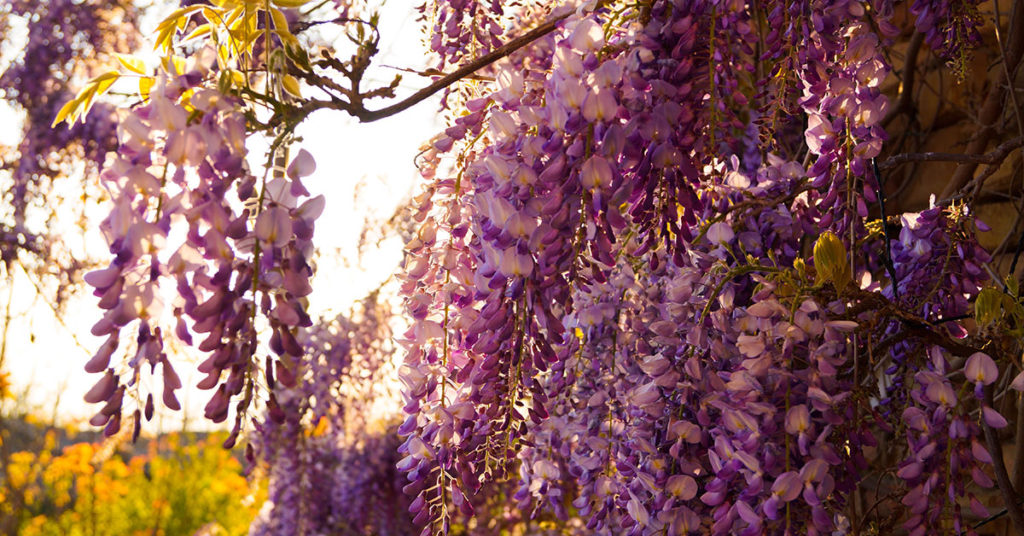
[86,49,324,443]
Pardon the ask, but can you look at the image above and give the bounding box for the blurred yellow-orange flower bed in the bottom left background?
[0,422,266,536]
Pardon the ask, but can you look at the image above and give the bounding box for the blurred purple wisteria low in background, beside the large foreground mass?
[250,295,418,536]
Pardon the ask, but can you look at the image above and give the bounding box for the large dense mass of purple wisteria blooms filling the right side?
[399,1,1005,534]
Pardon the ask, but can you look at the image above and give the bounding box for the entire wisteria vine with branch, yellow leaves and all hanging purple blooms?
[6,0,1024,535]
